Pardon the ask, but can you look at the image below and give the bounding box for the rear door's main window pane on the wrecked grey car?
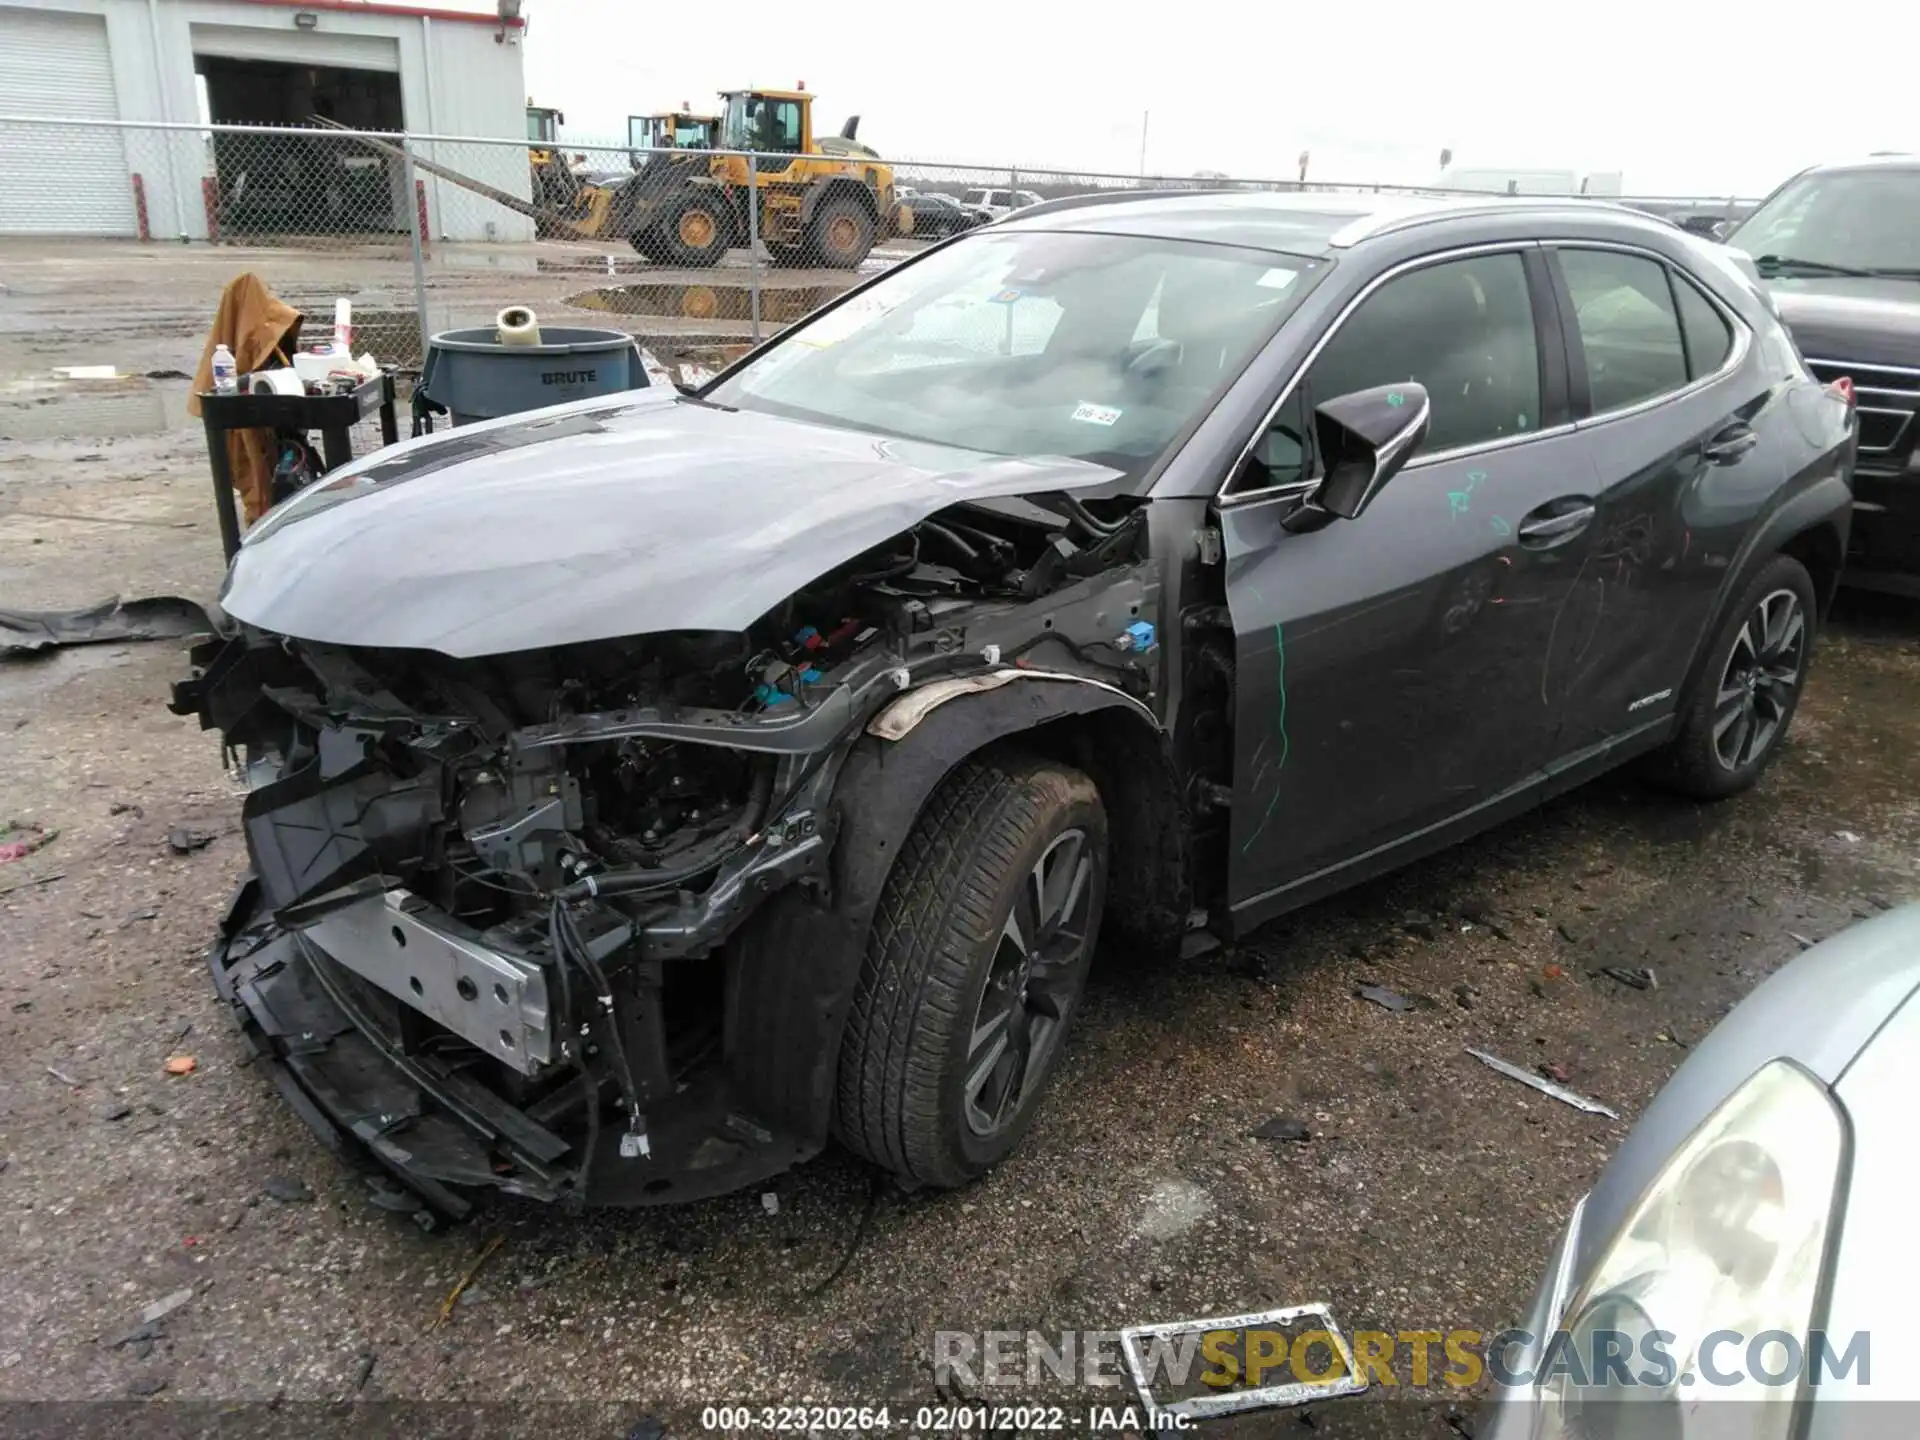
[1559,250,1688,415]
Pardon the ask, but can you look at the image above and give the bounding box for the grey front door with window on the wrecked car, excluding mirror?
[1219,248,1596,924]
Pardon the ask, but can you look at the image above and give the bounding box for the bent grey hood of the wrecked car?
[221,390,1119,657]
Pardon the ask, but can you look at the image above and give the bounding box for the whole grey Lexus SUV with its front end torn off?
[173,194,1855,1223]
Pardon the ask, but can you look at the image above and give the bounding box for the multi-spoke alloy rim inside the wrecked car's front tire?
[962,829,1092,1137]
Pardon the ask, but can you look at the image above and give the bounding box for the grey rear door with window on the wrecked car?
[1546,242,1782,758]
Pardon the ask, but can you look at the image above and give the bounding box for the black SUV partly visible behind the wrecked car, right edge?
[1726,156,1920,595]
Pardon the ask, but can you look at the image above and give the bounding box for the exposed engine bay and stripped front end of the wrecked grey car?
[173,493,1160,1213]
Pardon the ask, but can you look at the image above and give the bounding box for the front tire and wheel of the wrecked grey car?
[835,755,1108,1187]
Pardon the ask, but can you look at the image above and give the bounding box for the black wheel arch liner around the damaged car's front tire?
[726,676,1190,1144]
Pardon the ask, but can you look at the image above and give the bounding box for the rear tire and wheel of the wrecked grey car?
[1653,555,1820,801]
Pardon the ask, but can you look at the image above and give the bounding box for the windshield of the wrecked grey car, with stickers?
[707,230,1321,474]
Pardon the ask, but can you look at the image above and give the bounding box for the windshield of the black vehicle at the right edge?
[1728,169,1920,275]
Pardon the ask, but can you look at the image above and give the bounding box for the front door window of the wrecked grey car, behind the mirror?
[1233,253,1540,490]
